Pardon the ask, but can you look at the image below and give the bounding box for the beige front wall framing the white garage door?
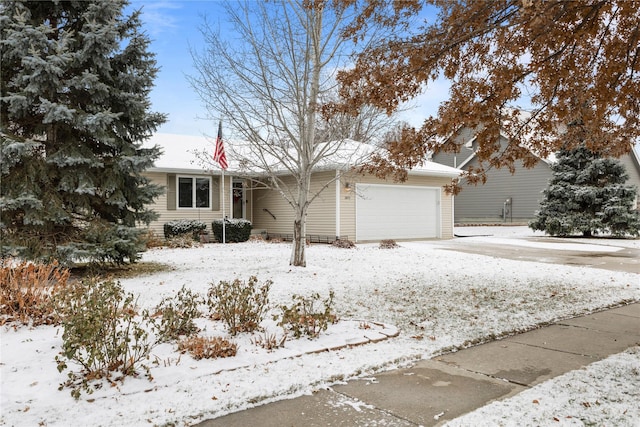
[340,175,453,240]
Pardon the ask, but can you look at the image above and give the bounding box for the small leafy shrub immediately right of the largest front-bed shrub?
[153,286,204,342]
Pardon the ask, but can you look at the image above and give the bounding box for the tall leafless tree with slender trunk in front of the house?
[190,0,387,266]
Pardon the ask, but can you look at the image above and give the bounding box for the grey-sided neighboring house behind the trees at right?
[432,129,640,224]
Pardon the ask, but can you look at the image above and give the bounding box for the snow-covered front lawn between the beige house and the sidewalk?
[0,227,640,426]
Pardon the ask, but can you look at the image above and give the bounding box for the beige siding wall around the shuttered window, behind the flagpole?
[144,172,230,236]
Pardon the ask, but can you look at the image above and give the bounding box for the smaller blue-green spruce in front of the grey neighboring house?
[529,145,640,237]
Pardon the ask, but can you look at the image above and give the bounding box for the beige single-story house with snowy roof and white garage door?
[145,134,461,242]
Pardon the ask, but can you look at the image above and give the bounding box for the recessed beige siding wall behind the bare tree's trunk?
[252,171,336,236]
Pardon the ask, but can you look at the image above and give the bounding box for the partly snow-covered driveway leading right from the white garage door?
[439,228,640,274]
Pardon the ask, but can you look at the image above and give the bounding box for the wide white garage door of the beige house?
[356,184,440,241]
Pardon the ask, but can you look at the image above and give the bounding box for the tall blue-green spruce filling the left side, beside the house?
[0,0,165,263]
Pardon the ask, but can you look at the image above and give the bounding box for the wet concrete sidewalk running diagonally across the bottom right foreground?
[198,304,640,427]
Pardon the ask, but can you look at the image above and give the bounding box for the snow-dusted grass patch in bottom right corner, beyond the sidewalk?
[445,347,640,427]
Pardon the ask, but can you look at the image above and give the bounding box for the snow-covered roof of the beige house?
[143,133,462,178]
